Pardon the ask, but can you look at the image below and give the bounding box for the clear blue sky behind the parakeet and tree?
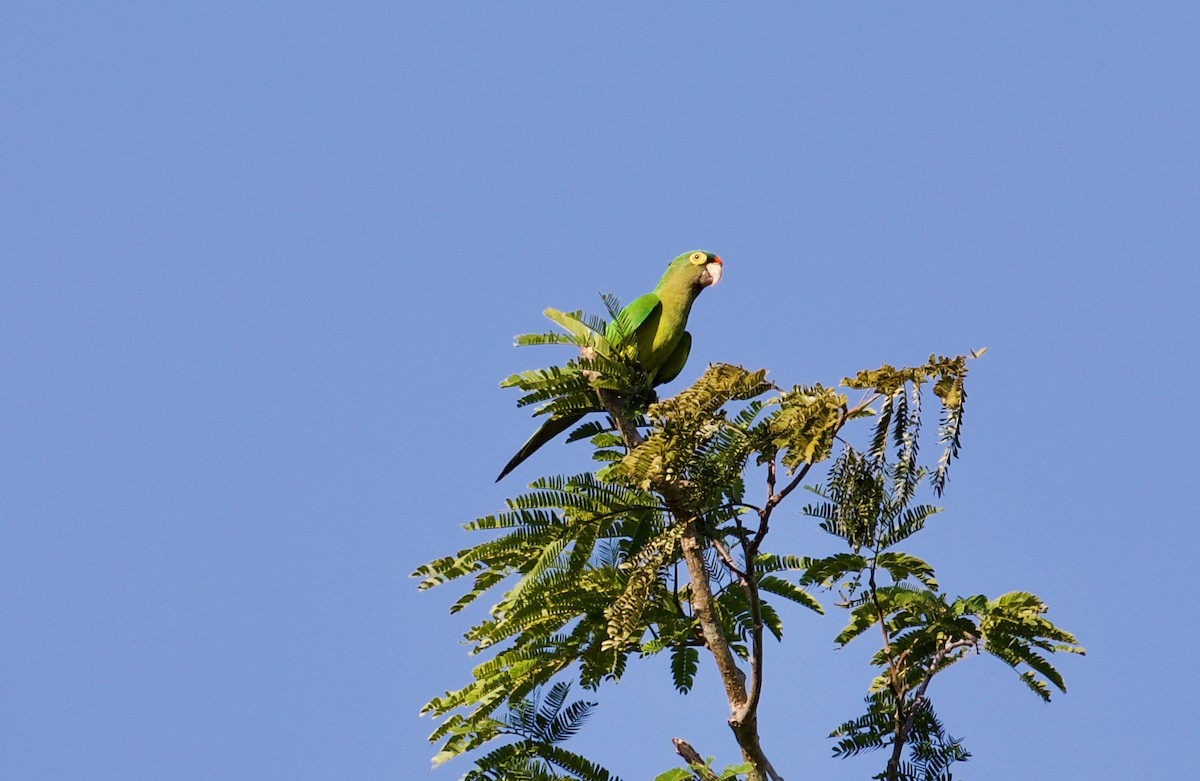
[0,2,1200,781]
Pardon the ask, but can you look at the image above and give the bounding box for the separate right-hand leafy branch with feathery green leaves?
[803,436,1082,781]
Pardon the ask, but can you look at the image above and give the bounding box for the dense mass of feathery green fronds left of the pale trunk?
[415,474,694,756]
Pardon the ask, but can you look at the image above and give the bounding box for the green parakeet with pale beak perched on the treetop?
[496,250,724,482]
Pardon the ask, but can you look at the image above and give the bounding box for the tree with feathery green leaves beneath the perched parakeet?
[414,303,1084,781]
